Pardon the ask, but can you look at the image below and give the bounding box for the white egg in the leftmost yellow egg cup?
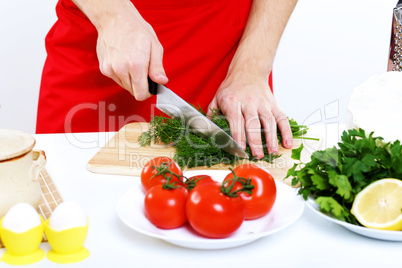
[3,203,42,233]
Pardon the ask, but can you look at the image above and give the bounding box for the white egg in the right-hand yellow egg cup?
[49,201,88,231]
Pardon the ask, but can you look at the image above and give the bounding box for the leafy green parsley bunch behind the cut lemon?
[287,129,402,225]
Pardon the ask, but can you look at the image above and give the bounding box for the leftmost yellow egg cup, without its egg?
[0,217,45,265]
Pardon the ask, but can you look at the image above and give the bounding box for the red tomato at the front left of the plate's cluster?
[144,184,188,229]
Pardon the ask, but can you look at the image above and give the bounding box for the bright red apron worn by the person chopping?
[36,0,272,133]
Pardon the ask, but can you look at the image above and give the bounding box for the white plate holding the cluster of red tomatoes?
[117,171,304,249]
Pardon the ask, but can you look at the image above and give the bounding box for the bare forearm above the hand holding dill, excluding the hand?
[229,0,297,77]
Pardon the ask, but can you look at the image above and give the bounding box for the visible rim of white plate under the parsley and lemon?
[306,197,402,241]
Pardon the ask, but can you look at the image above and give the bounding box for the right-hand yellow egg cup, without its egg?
[44,219,89,264]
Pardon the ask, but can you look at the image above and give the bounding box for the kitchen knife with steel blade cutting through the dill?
[148,78,249,158]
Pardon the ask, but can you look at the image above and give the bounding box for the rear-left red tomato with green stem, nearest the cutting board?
[141,156,183,192]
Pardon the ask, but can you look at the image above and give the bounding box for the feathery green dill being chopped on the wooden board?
[139,111,308,168]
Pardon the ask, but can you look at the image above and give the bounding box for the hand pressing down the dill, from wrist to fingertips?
[208,73,292,159]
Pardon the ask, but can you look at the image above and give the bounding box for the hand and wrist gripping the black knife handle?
[74,0,168,101]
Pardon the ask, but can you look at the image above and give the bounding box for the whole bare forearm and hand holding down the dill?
[209,0,297,159]
